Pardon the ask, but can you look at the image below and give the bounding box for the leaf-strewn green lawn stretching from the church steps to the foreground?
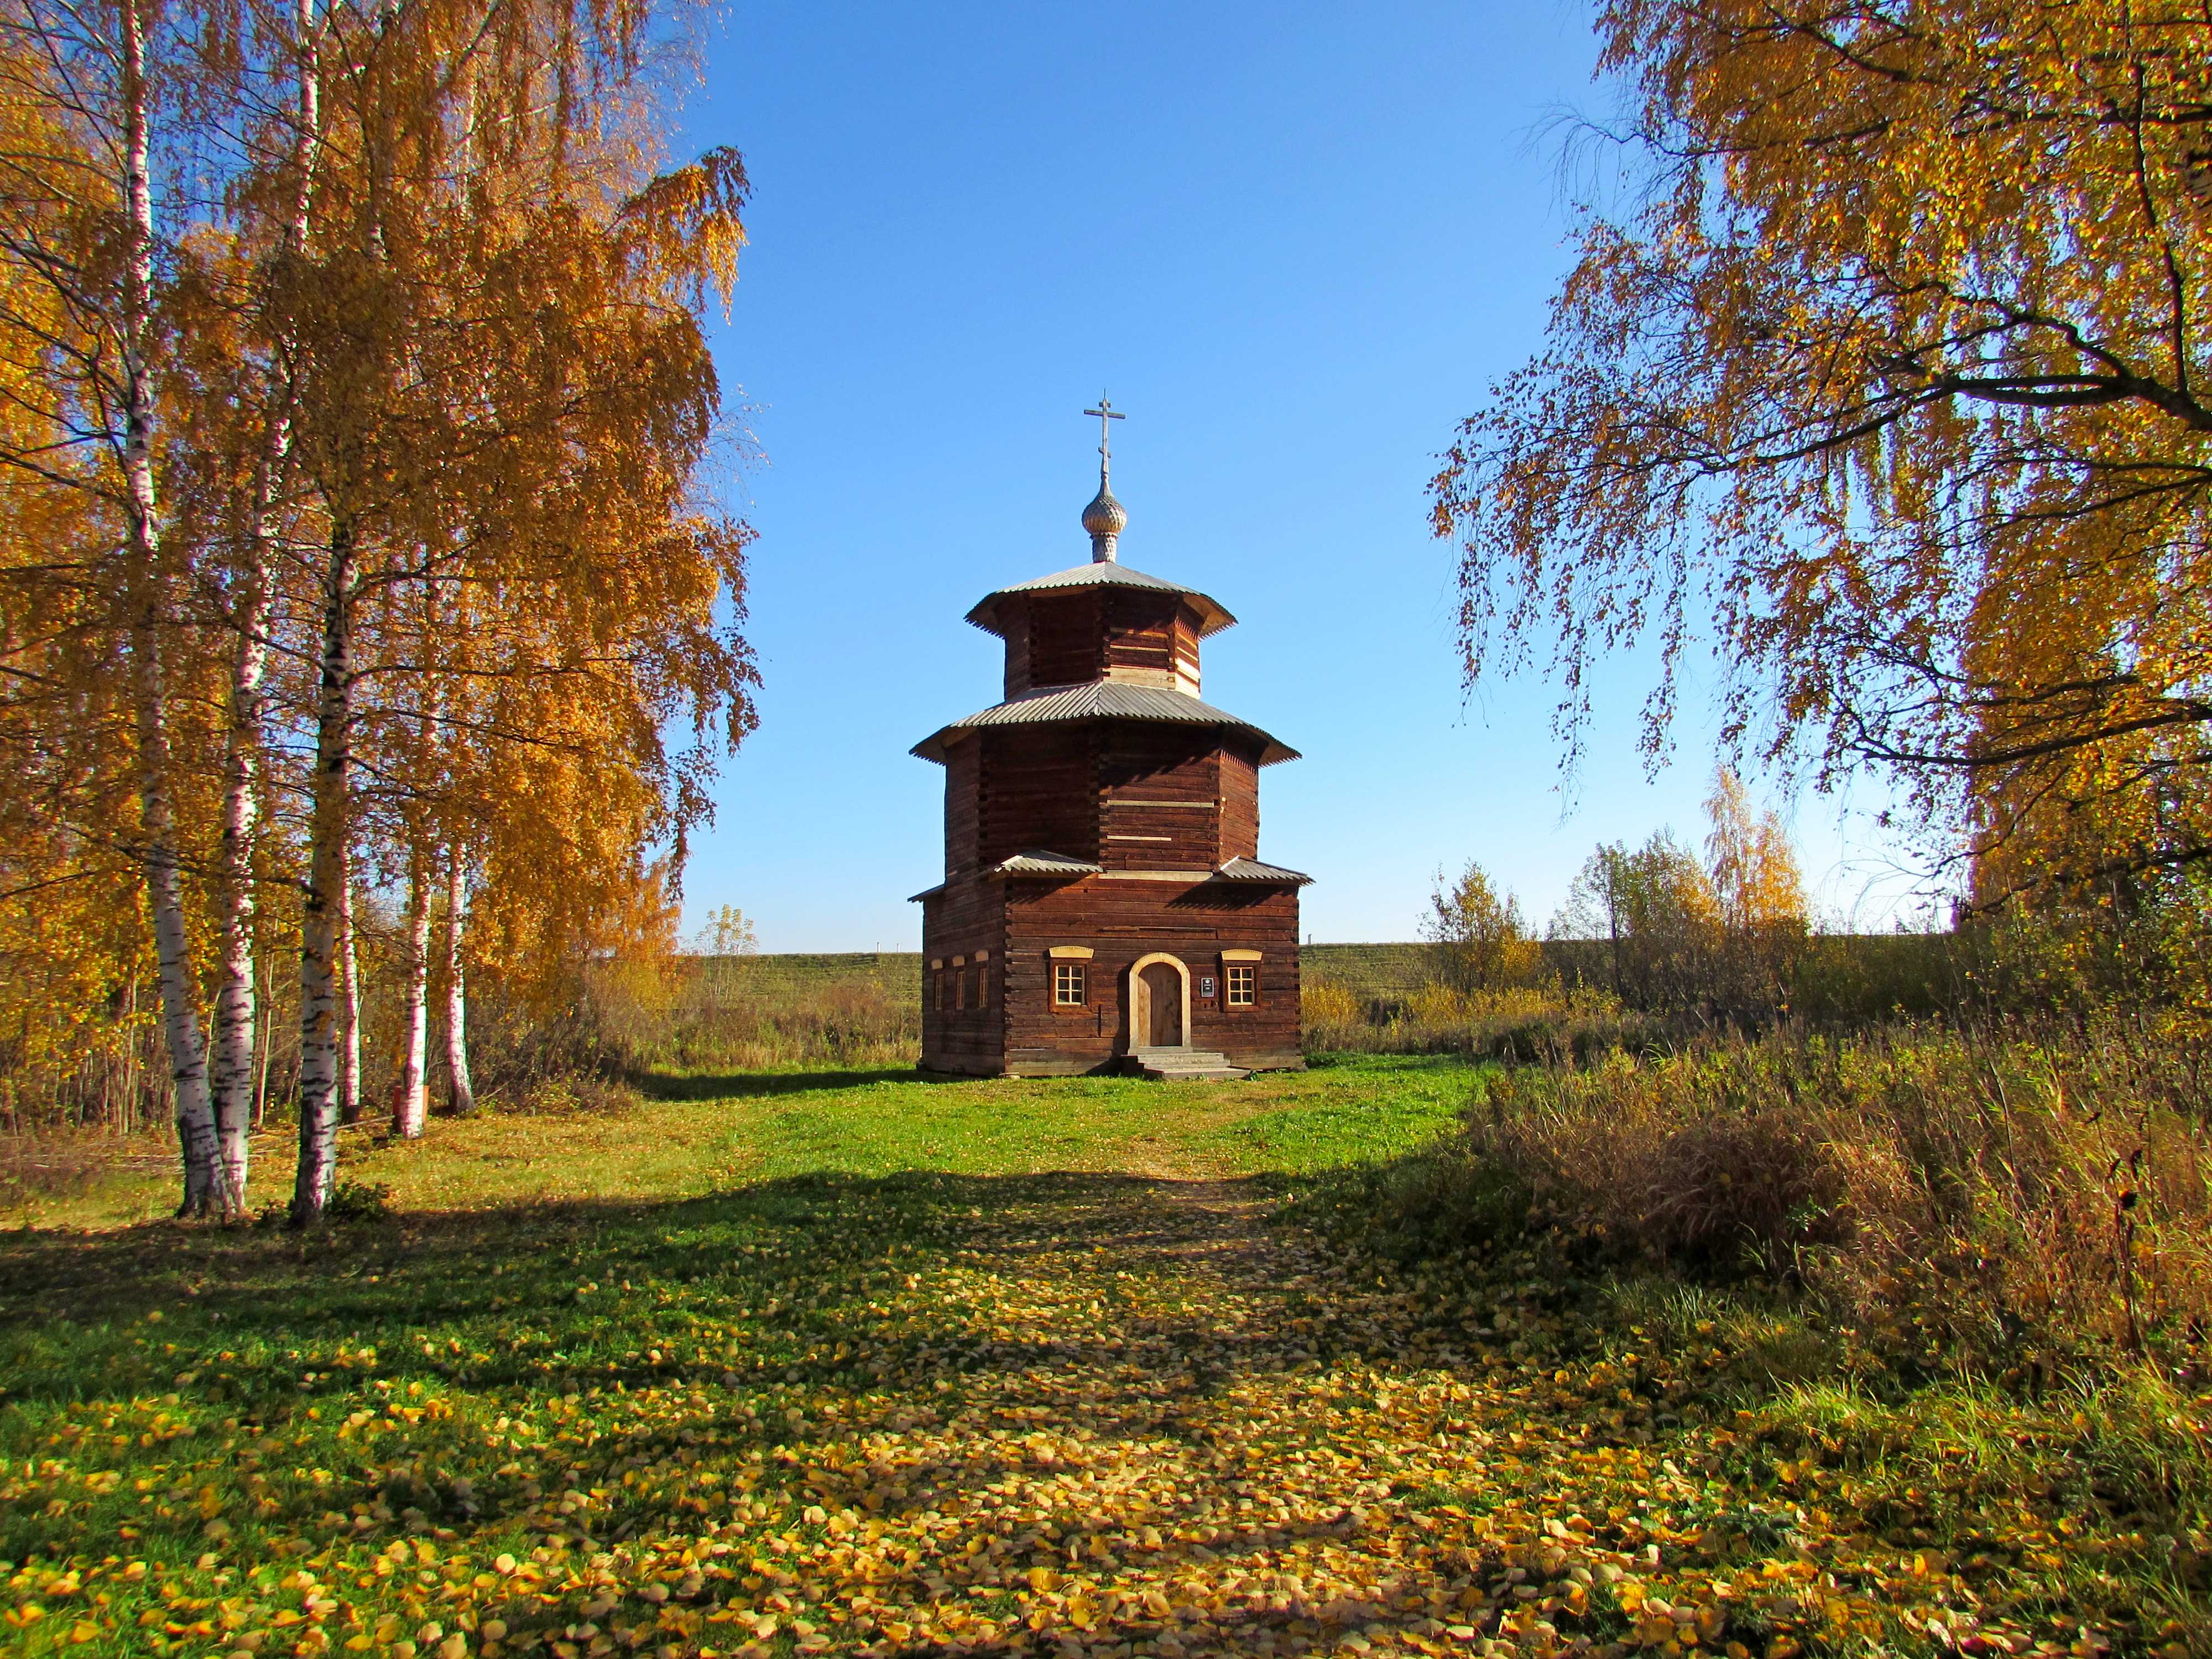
[0,1060,2192,1659]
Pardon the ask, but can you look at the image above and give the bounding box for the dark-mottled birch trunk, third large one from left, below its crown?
[292,518,356,1228]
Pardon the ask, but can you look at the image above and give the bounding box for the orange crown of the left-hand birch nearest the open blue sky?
[285,4,757,1009]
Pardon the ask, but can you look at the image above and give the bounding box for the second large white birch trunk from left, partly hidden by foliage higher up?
[215,0,321,1217]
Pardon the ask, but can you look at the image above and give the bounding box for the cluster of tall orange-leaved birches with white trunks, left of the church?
[0,0,752,1194]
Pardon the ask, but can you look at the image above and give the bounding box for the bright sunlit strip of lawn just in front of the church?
[22,1055,1478,1228]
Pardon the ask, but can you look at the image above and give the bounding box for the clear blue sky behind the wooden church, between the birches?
[684,0,1920,951]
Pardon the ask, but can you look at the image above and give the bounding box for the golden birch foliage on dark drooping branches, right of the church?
[1433,0,2212,898]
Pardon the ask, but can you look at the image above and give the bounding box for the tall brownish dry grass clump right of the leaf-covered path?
[1402,1029,2212,1380]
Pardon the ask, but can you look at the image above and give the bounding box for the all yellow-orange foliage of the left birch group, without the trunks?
[0,0,754,1141]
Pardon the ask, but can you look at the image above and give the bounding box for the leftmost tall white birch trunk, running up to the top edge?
[117,0,217,1214]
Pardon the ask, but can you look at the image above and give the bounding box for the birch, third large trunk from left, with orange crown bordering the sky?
[292,4,752,1223]
